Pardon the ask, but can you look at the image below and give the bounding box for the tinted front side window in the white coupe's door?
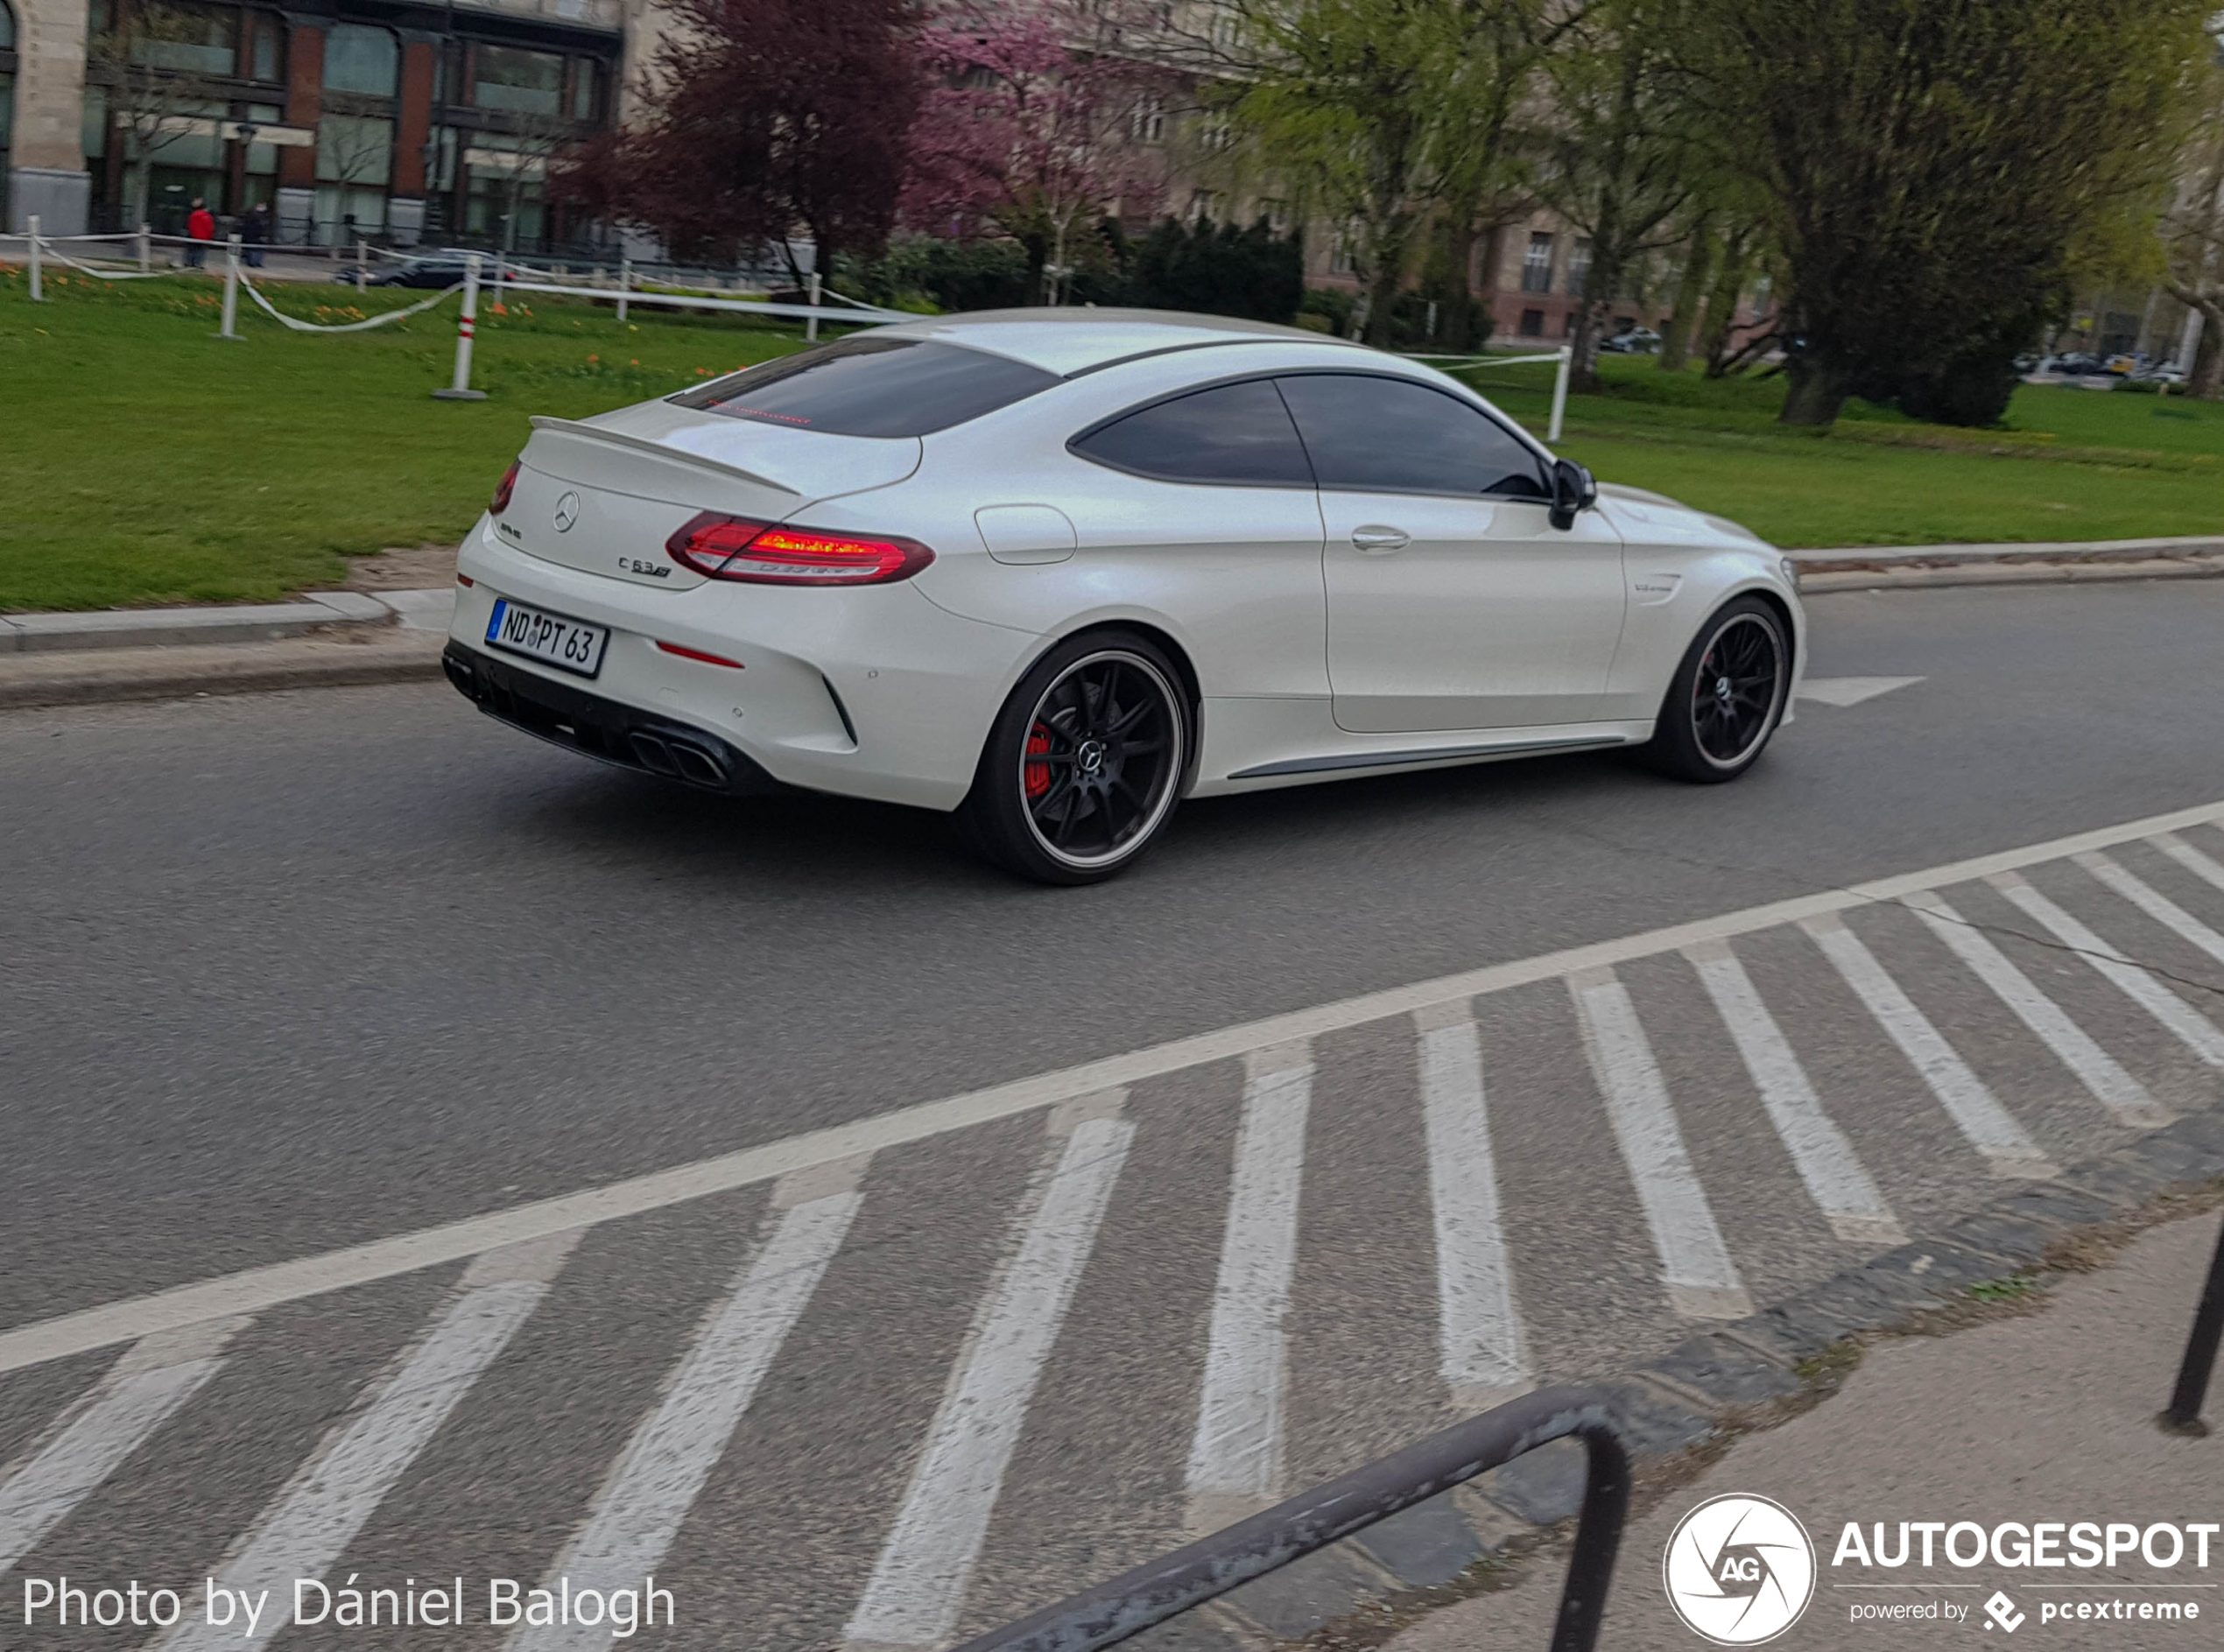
[1277,374,1552,498]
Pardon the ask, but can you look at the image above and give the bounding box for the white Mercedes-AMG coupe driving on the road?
[445,309,1804,882]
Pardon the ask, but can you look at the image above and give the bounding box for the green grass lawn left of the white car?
[0,271,818,609]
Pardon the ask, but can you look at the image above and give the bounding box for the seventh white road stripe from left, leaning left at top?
[1568,969,1753,1318]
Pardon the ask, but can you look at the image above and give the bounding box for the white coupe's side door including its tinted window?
[1277,371,1623,734]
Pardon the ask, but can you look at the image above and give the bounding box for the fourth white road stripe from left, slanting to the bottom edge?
[845,1102,1134,1648]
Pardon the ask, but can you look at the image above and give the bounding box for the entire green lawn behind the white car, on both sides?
[0,269,2224,609]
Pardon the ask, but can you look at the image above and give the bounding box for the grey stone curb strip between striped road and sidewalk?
[1123,1109,2224,1652]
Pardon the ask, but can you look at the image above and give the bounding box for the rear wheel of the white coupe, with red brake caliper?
[959,631,1194,885]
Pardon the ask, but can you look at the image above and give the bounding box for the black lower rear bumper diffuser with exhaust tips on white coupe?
[440,643,790,798]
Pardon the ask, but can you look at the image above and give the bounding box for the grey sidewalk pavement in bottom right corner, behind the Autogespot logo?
[1388,1214,2224,1652]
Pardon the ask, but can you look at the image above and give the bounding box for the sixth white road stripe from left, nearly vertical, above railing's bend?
[1414,1002,1532,1412]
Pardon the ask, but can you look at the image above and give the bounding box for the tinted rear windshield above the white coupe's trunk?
[672,335,1059,436]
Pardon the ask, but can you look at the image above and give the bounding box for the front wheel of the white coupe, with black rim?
[1642,596,1792,785]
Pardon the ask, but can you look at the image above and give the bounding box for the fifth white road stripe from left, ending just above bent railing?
[1186,1045,1313,1534]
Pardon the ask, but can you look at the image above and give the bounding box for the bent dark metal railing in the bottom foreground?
[959,1388,1630,1652]
